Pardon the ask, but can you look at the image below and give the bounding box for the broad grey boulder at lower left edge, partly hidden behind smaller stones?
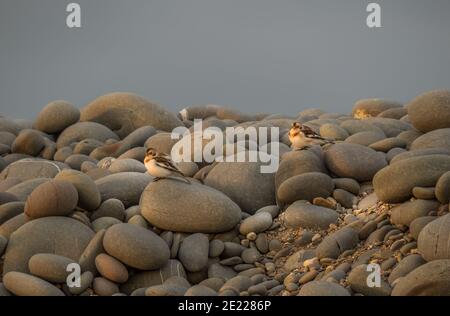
[3,216,94,274]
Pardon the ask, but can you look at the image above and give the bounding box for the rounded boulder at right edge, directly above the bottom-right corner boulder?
[417,214,450,261]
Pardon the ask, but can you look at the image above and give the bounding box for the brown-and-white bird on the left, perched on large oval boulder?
[144,148,191,184]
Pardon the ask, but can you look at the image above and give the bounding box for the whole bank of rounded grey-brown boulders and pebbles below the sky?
[0,90,450,296]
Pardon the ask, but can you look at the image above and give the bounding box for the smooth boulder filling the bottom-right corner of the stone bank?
[392,259,450,296]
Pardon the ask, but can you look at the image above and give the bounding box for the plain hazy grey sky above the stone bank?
[0,0,450,118]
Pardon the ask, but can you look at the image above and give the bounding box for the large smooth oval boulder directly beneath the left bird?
[139,179,241,233]
